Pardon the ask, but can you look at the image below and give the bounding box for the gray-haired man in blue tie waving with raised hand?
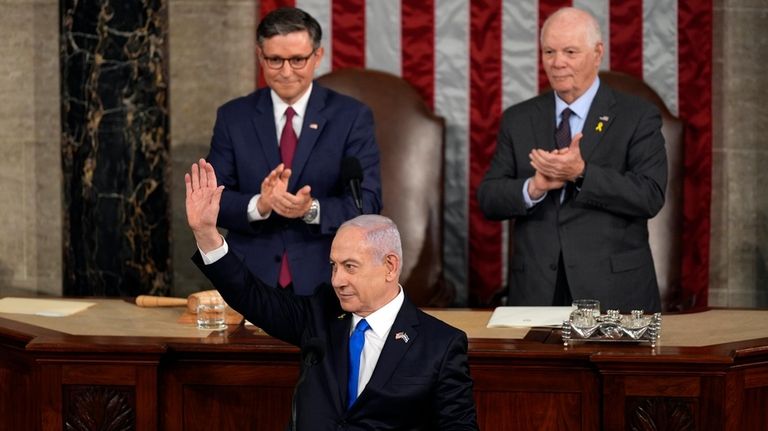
[185,160,477,430]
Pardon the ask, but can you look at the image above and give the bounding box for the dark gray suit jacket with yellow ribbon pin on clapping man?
[477,84,667,311]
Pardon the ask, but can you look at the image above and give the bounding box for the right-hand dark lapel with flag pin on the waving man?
[355,298,419,405]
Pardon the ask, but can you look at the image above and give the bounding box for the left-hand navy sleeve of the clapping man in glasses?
[207,108,258,233]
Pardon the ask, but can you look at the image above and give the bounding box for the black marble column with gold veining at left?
[61,0,172,296]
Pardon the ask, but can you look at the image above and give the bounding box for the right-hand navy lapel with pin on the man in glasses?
[288,83,328,190]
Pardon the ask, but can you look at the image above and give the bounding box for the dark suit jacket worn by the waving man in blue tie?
[193,252,477,431]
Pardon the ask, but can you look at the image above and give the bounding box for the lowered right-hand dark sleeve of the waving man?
[433,332,478,430]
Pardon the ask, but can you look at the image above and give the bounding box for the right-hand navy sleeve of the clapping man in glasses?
[318,105,381,234]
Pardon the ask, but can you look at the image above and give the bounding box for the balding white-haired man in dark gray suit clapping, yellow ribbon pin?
[477,8,667,311]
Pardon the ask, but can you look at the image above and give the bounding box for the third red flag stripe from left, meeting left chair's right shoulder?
[400,0,435,109]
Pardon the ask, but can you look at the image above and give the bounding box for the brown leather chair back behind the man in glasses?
[316,69,455,306]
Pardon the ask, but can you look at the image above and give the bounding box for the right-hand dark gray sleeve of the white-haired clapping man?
[574,103,667,219]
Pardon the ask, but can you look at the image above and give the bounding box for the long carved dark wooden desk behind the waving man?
[0,302,768,431]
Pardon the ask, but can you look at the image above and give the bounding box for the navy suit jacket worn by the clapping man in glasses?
[207,83,381,295]
